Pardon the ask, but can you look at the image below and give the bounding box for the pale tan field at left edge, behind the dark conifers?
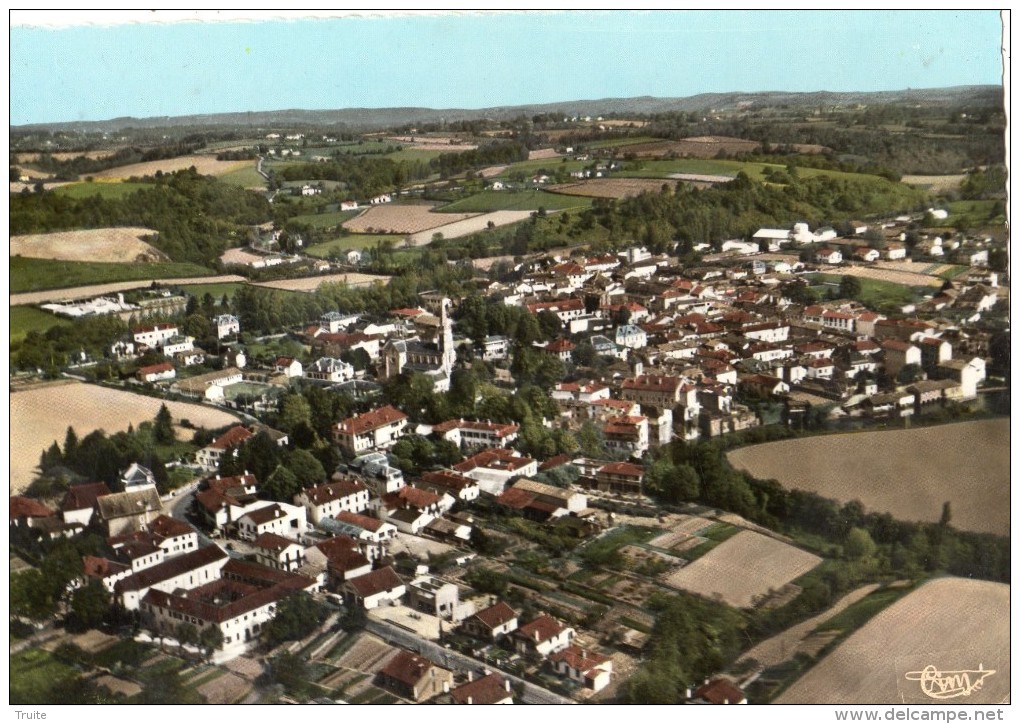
[10,381,238,495]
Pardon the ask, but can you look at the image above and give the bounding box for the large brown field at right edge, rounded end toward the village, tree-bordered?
[728,419,1010,535]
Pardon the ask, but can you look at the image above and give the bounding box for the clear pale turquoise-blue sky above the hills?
[10,10,1002,125]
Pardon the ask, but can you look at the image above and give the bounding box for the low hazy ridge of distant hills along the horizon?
[11,86,1003,132]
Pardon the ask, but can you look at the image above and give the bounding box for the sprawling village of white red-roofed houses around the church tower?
[10,200,1006,704]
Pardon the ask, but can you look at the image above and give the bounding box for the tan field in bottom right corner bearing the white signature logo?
[776,578,1010,706]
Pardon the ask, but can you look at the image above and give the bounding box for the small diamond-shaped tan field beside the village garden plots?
[662,530,822,608]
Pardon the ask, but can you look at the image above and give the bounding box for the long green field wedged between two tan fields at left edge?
[10,256,214,294]
